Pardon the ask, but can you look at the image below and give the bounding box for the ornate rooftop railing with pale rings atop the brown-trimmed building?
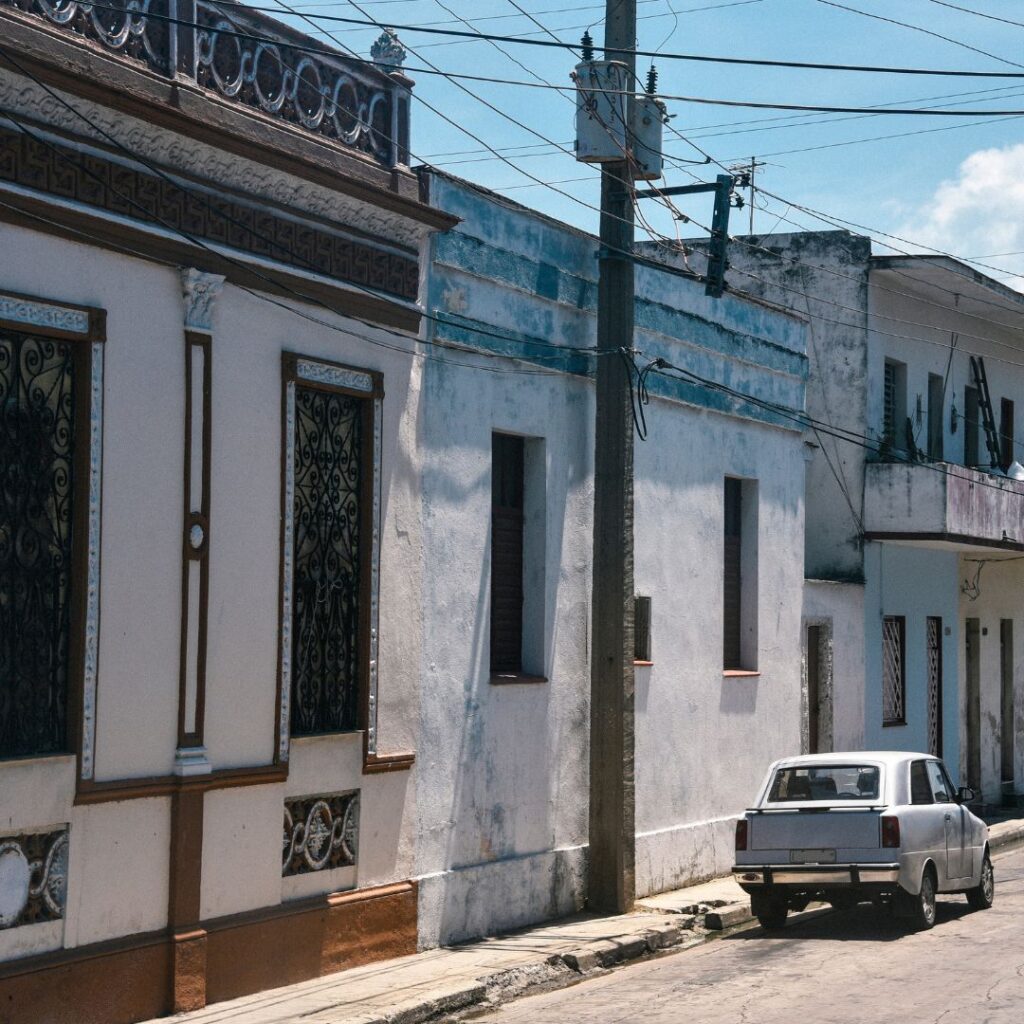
[0,0,410,167]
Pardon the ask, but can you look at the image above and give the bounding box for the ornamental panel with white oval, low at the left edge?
[0,825,68,930]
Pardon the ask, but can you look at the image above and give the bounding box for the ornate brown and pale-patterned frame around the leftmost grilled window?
[0,291,106,770]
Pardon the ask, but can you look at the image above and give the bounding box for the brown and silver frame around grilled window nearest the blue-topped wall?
[275,351,384,770]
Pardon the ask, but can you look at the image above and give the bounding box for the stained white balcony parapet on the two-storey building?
[864,462,1024,551]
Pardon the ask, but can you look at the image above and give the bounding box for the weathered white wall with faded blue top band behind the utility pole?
[417,175,806,921]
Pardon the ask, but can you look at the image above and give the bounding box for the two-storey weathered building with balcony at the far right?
[733,231,1024,805]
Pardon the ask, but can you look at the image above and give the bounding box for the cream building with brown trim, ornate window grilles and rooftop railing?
[0,2,453,1022]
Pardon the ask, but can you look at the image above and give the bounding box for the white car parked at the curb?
[732,751,994,929]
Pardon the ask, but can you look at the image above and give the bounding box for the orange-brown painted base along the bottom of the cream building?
[0,882,417,1024]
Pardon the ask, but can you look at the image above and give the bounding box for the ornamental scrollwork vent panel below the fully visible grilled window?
[281,790,359,878]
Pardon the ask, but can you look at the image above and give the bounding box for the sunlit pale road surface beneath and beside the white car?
[468,849,1024,1024]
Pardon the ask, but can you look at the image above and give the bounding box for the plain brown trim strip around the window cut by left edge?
[0,290,106,774]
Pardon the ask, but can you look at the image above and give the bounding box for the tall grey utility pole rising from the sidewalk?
[587,0,636,913]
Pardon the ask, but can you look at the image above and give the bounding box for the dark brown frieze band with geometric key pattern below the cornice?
[0,129,419,302]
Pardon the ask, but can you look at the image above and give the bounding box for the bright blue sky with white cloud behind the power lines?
[270,0,1024,291]
